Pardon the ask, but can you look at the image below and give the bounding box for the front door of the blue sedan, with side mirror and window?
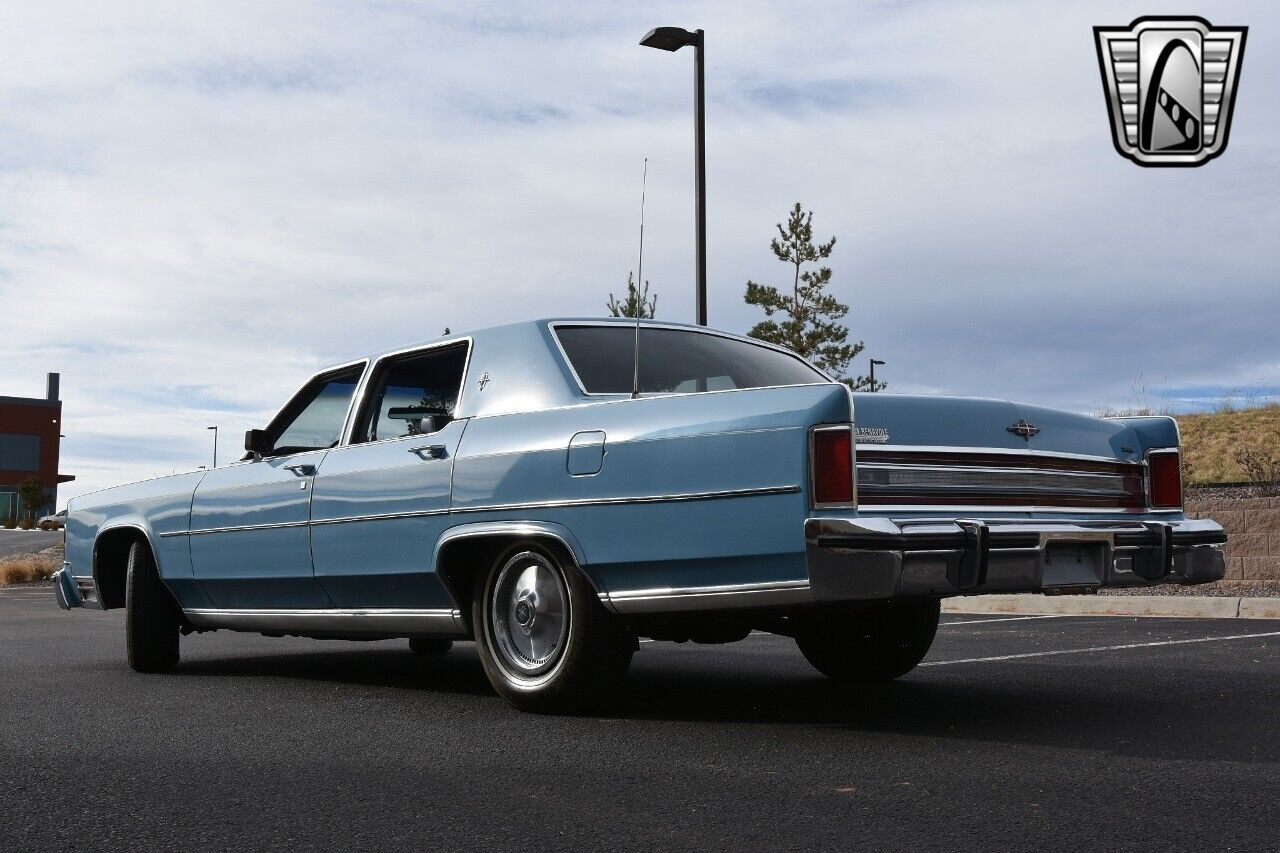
[191,362,365,610]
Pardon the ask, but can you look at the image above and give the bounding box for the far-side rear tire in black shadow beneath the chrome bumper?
[796,598,941,681]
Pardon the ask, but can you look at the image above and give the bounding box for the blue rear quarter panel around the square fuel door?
[452,384,850,592]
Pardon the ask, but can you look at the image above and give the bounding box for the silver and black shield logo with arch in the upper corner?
[1093,17,1249,167]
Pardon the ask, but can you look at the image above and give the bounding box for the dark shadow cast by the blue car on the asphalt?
[178,644,1280,763]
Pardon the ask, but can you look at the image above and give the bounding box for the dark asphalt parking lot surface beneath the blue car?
[0,589,1280,850]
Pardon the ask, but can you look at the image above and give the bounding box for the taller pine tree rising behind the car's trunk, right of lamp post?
[745,201,884,391]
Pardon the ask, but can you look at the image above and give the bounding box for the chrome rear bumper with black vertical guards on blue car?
[805,517,1226,601]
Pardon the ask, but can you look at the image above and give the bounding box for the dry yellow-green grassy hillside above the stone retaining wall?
[1178,405,1280,483]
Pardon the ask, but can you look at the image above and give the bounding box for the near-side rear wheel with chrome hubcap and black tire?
[471,542,636,713]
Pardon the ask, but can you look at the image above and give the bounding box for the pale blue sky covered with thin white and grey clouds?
[0,0,1280,503]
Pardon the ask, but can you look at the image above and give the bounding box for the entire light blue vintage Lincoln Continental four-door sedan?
[56,320,1226,711]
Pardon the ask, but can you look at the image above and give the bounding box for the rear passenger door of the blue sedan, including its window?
[311,341,471,610]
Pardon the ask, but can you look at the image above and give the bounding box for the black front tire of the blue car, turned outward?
[124,542,182,672]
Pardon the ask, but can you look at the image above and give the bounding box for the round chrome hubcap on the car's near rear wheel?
[489,551,568,678]
